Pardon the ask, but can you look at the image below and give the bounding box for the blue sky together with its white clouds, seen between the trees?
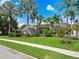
[0,0,64,26]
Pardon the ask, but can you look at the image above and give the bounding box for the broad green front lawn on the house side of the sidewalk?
[1,36,79,51]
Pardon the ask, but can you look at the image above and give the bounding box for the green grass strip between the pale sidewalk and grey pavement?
[0,41,79,59]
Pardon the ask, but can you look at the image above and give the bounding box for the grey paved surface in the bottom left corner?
[0,46,36,59]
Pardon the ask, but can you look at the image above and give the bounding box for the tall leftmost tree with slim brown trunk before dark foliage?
[2,1,16,34]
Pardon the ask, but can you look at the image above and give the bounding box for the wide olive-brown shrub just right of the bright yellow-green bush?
[54,26,71,37]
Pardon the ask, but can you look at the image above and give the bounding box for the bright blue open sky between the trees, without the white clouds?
[12,0,64,17]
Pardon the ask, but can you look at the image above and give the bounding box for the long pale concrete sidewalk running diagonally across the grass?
[0,39,79,58]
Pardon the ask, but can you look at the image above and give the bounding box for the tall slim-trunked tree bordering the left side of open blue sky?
[20,0,36,26]
